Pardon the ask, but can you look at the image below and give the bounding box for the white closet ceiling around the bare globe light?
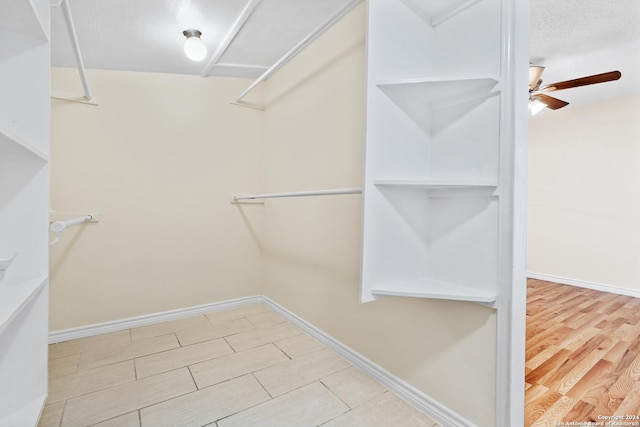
[51,0,356,77]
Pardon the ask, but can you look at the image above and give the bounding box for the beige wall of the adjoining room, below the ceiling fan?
[527,95,640,291]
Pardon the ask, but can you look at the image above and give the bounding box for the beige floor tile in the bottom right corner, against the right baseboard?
[323,391,438,427]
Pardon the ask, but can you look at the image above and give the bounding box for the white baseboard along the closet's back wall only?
[49,295,264,344]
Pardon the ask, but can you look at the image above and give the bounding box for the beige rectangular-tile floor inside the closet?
[39,304,438,427]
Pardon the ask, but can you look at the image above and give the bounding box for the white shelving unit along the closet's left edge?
[0,0,50,426]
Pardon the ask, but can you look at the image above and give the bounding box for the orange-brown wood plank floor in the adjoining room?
[525,279,640,427]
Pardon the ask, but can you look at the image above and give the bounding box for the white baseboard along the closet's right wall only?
[262,296,475,427]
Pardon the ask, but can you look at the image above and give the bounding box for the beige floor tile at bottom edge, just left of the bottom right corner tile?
[218,382,349,427]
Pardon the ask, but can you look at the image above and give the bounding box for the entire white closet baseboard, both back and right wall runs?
[49,295,475,427]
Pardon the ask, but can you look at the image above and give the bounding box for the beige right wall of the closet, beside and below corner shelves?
[263,5,496,426]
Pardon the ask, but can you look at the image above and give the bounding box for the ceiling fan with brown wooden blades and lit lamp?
[529,65,622,114]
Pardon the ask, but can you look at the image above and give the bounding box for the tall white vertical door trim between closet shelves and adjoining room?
[495,0,529,427]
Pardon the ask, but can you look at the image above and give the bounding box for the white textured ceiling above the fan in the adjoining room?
[530,0,640,105]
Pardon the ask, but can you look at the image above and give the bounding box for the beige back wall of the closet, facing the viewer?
[50,69,262,330]
